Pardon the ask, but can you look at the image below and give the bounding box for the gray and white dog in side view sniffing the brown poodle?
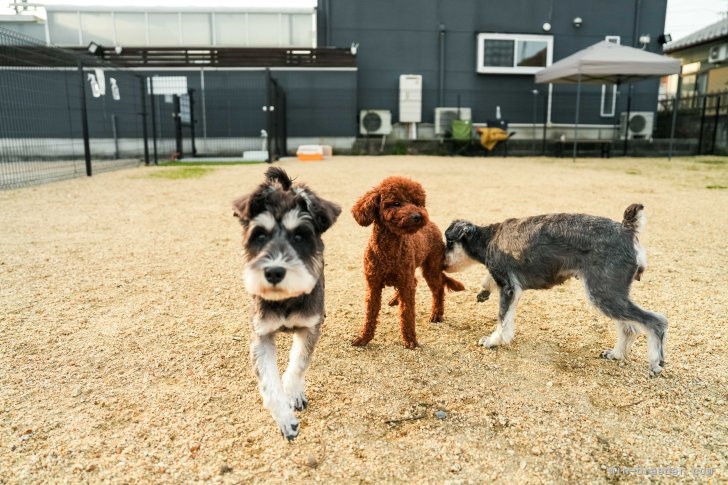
[445,204,667,374]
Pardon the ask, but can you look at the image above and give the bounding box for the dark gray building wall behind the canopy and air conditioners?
[318,0,666,124]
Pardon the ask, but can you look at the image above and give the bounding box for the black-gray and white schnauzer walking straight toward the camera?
[233,167,341,441]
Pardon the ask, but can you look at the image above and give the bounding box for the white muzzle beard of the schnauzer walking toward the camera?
[243,253,320,301]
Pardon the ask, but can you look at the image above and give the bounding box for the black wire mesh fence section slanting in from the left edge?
[0,29,149,189]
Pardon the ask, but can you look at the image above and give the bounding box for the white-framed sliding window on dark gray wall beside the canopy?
[477,34,553,74]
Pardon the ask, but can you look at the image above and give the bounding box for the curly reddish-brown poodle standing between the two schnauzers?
[351,177,465,349]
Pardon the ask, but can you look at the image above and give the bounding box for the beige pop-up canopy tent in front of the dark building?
[536,41,680,159]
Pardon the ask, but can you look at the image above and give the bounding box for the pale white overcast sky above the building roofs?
[5,0,728,40]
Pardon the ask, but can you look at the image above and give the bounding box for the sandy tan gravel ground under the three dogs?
[0,157,728,483]
